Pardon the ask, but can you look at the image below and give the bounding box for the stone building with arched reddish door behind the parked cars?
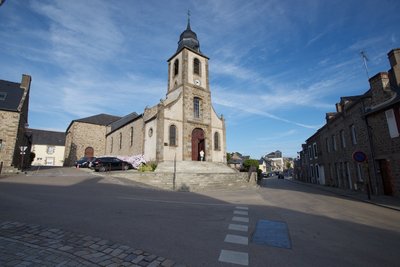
[64,114,121,166]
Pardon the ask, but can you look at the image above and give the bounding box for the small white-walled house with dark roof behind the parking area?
[28,129,65,166]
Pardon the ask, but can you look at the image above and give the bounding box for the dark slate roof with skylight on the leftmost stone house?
[0,80,24,111]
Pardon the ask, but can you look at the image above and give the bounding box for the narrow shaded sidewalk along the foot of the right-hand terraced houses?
[285,178,400,211]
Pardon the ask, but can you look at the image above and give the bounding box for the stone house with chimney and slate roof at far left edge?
[0,74,32,173]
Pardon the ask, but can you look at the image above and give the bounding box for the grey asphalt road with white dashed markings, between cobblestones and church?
[0,168,400,266]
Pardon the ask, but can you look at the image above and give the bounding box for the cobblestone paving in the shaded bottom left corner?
[0,222,184,267]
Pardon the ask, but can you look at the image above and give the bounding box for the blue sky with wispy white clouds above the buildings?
[0,0,400,159]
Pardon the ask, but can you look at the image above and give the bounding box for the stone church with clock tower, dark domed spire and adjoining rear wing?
[65,19,226,165]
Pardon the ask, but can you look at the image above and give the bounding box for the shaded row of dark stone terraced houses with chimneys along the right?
[296,49,400,196]
